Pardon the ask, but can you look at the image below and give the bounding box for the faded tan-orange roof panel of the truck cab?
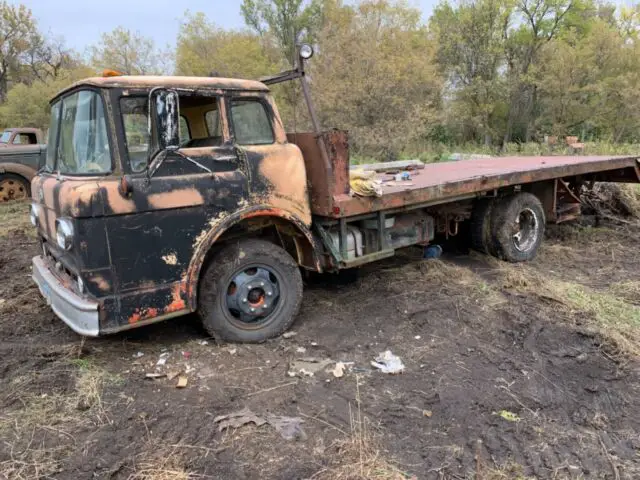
[54,75,269,98]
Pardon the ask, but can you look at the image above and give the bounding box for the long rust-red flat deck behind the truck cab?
[331,156,640,218]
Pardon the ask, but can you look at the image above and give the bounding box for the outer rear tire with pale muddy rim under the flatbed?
[491,192,546,263]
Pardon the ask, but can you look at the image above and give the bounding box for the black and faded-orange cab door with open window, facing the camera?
[101,95,247,321]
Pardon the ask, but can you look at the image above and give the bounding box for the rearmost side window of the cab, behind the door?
[231,99,274,145]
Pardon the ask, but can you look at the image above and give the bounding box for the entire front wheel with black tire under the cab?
[198,239,302,343]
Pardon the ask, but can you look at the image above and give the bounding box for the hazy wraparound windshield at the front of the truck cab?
[47,90,111,175]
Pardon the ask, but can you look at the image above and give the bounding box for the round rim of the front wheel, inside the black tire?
[224,265,282,329]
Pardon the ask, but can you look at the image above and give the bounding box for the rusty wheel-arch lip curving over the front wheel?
[187,205,321,310]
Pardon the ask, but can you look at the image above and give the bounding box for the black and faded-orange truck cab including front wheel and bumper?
[31,71,317,341]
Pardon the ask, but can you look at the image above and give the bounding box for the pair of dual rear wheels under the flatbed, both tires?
[471,192,546,263]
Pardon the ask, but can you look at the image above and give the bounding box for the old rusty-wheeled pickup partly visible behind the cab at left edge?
[0,128,46,203]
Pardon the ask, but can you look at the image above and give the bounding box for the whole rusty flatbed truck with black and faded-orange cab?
[31,47,640,342]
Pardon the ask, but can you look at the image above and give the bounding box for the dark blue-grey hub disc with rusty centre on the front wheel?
[226,267,280,323]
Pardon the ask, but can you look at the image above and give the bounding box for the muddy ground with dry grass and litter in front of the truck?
[0,200,640,479]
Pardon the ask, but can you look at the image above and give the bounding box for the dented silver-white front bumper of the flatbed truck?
[32,256,100,337]
